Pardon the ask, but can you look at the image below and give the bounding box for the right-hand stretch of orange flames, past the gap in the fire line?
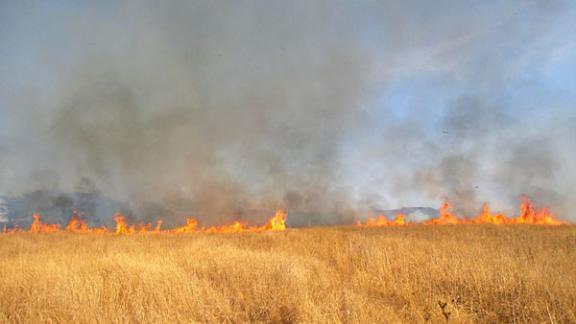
[356,197,563,227]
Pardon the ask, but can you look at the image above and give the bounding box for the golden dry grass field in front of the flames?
[0,225,576,323]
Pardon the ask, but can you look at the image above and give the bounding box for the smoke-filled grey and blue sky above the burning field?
[0,0,576,223]
